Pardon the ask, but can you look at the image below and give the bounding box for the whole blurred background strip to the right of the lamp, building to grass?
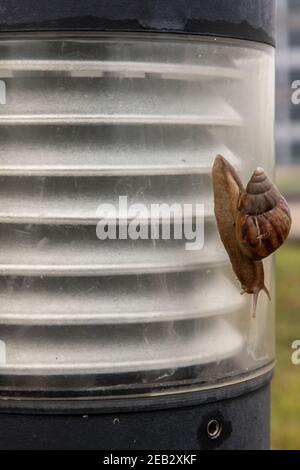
[272,0,300,450]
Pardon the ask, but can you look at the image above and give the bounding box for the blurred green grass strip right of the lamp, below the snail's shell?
[271,244,300,450]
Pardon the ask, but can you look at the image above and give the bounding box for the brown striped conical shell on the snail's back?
[235,168,291,260]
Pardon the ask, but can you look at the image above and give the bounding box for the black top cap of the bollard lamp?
[0,0,275,45]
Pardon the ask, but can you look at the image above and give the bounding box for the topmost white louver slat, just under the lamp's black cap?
[0,36,243,75]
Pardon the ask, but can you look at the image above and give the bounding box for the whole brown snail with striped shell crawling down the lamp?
[212,155,291,316]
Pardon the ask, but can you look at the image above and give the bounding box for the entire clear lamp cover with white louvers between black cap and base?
[0,35,273,397]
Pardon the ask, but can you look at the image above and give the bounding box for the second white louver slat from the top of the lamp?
[0,77,242,126]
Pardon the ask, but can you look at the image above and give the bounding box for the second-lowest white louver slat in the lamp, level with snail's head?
[0,269,246,326]
